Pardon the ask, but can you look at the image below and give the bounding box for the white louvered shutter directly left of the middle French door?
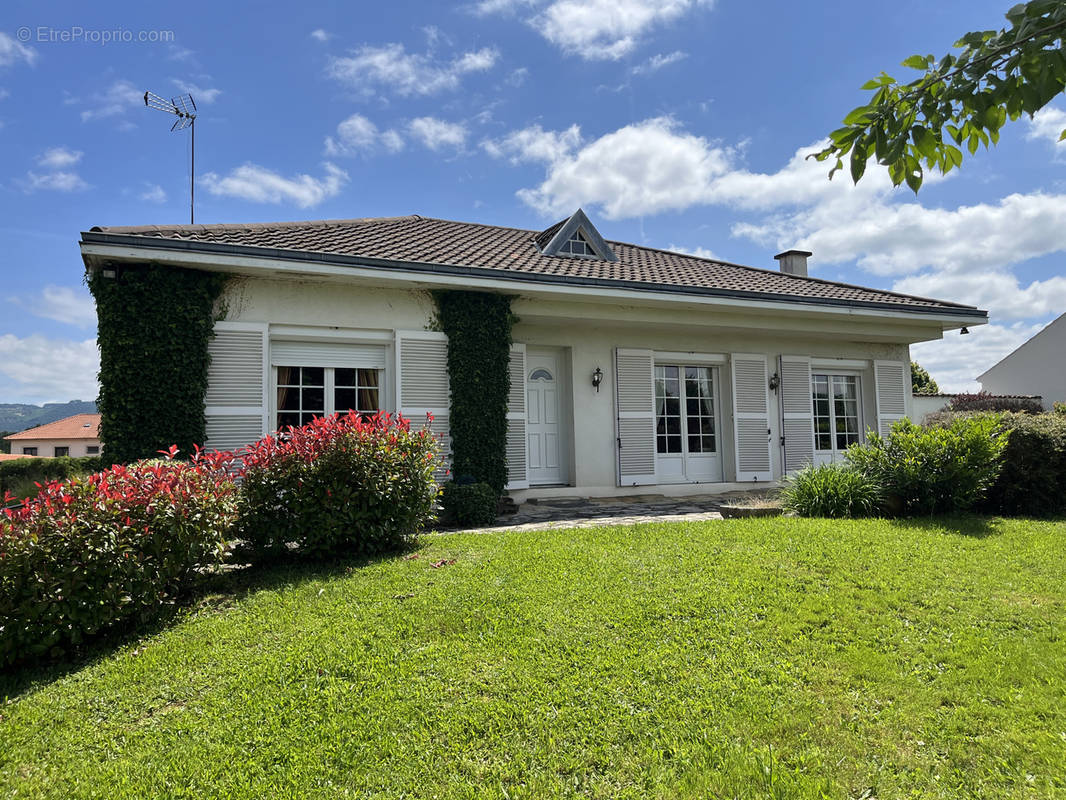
[614,348,656,486]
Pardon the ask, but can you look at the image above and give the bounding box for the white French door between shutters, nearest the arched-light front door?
[655,364,722,483]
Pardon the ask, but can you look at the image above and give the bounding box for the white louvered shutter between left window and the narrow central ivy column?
[395,331,452,481]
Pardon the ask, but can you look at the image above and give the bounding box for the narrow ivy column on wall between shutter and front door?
[433,291,515,493]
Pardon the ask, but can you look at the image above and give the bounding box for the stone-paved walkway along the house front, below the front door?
[439,493,776,533]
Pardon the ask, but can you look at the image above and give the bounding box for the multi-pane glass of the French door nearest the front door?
[656,365,716,453]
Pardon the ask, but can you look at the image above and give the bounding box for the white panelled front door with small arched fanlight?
[526,351,567,485]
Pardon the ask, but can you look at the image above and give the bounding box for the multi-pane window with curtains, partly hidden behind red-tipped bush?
[277,367,382,428]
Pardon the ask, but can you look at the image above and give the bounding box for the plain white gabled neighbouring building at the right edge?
[978,314,1066,409]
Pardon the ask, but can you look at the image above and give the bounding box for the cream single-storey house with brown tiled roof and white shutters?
[81,210,987,499]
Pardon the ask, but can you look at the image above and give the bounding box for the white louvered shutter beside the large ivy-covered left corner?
[204,322,270,450]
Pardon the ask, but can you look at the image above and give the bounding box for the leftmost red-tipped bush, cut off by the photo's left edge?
[0,453,237,667]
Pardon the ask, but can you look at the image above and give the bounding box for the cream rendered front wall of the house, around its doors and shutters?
[216,278,940,497]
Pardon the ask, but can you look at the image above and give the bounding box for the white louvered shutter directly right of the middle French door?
[730,353,773,481]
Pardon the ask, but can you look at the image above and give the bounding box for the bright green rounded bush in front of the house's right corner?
[844,415,1006,515]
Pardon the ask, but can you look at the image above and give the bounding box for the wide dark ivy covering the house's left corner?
[87,265,226,463]
